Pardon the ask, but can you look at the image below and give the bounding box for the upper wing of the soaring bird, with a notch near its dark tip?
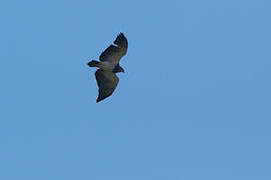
[99,33,128,65]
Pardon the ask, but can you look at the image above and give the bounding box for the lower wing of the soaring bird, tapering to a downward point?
[95,69,119,102]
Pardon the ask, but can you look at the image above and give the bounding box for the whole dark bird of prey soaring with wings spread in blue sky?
[88,33,128,102]
